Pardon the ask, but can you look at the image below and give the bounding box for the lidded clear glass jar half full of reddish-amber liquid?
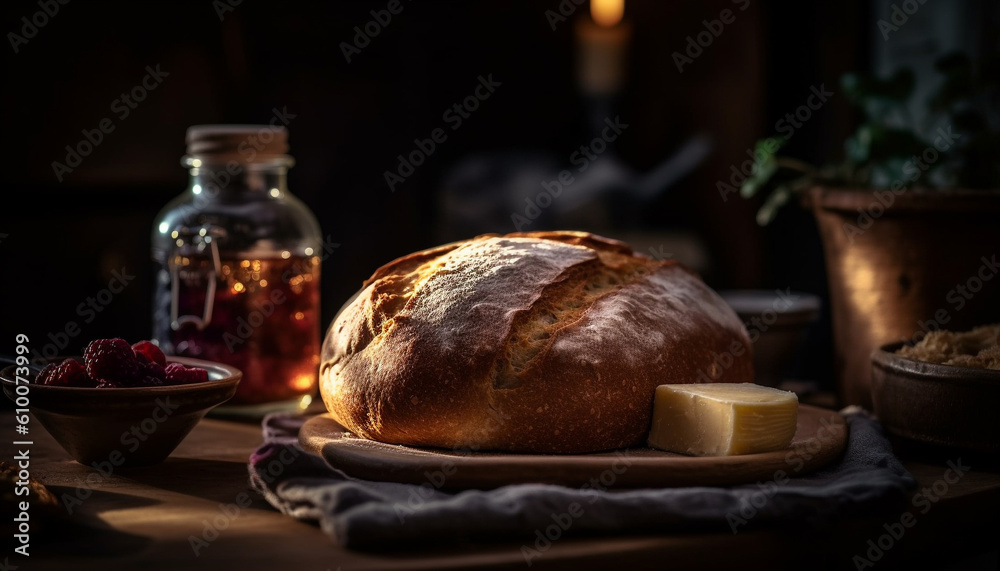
[152,125,322,413]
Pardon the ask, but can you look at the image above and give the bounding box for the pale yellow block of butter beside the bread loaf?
[648,383,799,456]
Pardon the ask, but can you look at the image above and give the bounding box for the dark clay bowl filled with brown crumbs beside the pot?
[872,342,1000,455]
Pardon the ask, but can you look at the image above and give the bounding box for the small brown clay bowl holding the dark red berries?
[0,356,243,469]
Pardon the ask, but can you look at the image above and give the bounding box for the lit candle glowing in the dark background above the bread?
[575,0,632,96]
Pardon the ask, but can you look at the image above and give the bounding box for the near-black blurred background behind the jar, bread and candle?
[0,0,996,394]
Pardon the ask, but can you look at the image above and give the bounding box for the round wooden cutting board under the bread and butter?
[299,405,847,489]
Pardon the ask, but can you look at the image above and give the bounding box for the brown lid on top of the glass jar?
[187,125,288,162]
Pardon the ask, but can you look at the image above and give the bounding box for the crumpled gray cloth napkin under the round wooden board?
[249,407,916,548]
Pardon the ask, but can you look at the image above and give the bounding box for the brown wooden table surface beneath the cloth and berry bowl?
[0,402,1000,571]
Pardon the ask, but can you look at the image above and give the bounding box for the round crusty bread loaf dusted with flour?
[320,232,754,453]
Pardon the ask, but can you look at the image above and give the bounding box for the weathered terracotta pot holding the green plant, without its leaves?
[805,188,1000,410]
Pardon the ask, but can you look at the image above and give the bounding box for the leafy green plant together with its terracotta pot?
[740,48,1000,409]
